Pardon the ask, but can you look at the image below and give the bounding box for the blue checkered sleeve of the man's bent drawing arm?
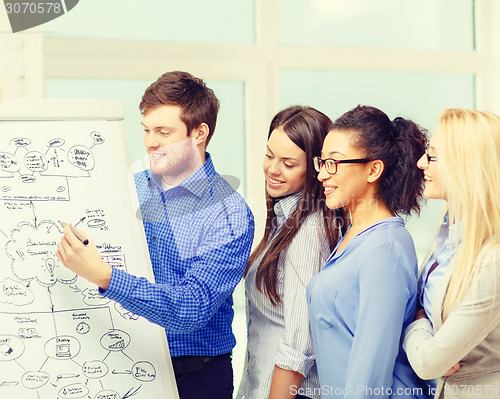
[102,205,254,332]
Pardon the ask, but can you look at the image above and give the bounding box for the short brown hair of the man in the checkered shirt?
[139,71,219,144]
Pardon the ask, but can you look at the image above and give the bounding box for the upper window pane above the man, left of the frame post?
[43,0,255,44]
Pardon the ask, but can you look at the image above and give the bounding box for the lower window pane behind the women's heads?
[280,70,475,260]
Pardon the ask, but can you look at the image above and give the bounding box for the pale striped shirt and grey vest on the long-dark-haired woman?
[237,192,330,399]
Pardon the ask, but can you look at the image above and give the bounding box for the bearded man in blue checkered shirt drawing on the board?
[57,71,254,399]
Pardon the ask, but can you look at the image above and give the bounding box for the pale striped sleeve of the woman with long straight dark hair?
[274,214,329,377]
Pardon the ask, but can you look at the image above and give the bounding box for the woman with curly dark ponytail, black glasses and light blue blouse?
[307,106,427,398]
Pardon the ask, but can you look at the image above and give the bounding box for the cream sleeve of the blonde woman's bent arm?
[403,253,500,379]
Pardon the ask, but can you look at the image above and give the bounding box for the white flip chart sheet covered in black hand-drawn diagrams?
[0,122,172,399]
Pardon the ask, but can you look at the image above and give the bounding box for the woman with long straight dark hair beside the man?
[238,106,344,399]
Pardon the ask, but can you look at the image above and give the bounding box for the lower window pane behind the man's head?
[45,79,245,194]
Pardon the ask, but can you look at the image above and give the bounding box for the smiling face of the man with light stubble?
[141,105,200,185]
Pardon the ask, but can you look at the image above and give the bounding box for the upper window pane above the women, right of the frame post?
[279,0,474,50]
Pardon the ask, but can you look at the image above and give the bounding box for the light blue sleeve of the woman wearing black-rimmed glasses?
[346,241,417,398]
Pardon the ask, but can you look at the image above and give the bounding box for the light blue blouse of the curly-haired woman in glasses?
[307,217,426,399]
